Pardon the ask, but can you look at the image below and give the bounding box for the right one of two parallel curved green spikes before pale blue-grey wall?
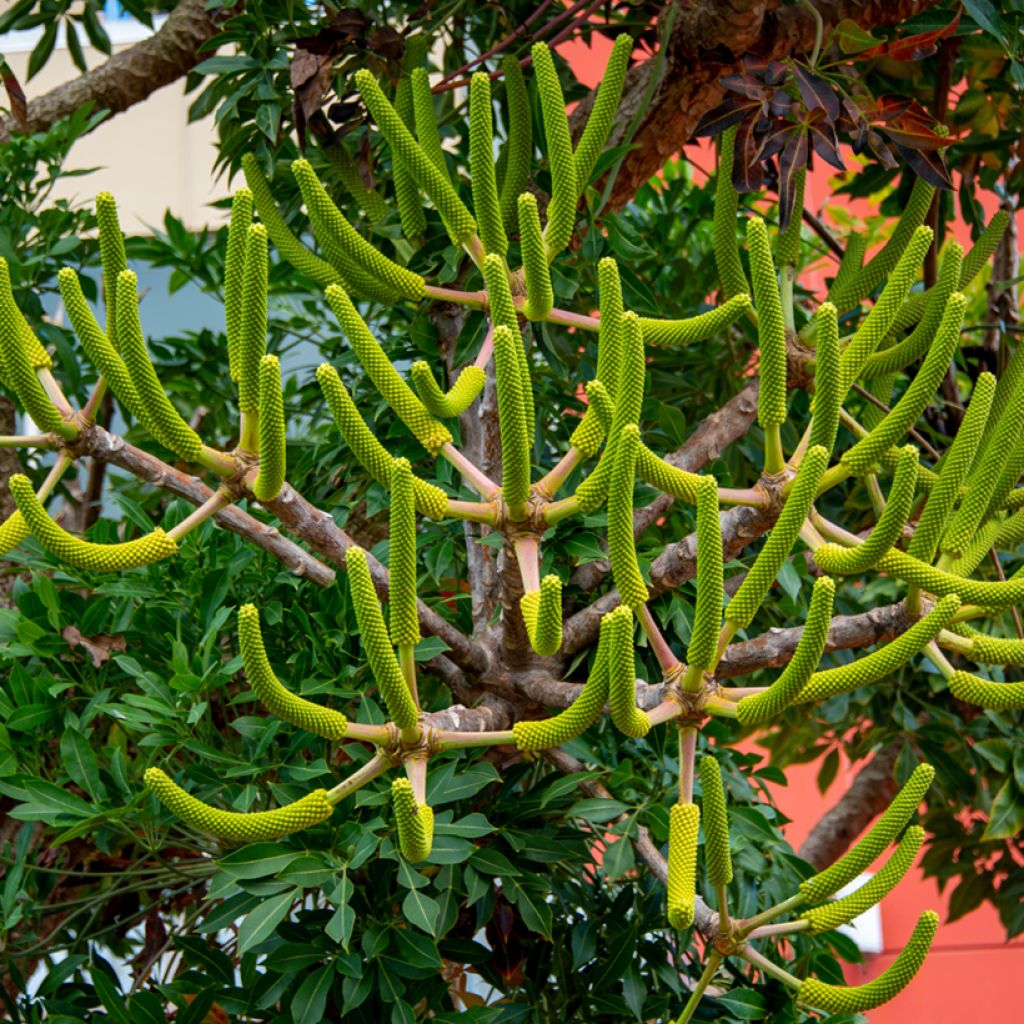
[118,270,203,462]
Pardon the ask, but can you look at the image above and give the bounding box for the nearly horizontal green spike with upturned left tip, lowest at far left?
[145,768,334,843]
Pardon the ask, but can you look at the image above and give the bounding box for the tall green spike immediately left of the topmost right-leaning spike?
[530,43,580,263]
